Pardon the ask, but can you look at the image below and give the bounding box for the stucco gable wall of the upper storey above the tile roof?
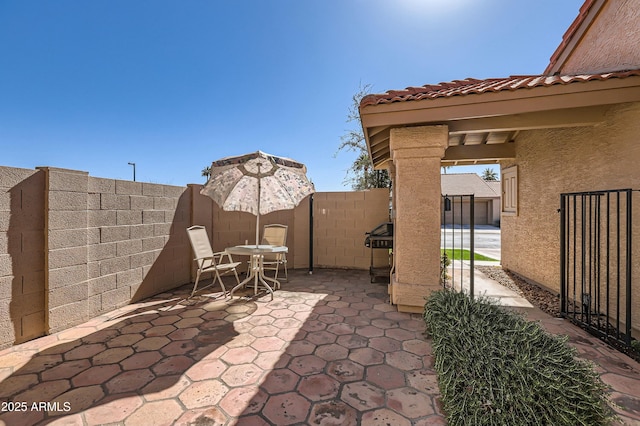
[561,0,640,74]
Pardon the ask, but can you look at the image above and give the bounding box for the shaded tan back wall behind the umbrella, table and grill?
[191,185,389,269]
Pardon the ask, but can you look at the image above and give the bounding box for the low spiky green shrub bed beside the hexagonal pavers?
[424,290,612,426]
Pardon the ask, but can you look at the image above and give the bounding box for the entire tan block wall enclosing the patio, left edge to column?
[0,167,389,348]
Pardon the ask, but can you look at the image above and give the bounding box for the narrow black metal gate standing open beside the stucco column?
[440,194,475,298]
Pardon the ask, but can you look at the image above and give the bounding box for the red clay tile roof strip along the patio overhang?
[360,69,640,108]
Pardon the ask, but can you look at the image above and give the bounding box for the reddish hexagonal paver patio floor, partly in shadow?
[0,270,640,426]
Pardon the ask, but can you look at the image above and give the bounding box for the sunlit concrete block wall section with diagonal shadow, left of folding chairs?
[87,178,191,306]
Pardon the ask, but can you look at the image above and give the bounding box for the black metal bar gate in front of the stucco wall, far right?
[560,189,633,348]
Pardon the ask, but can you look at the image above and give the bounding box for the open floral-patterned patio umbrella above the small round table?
[200,151,315,245]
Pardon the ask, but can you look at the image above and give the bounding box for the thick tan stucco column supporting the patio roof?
[390,126,448,312]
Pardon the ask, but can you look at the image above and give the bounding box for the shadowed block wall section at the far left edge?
[0,167,45,348]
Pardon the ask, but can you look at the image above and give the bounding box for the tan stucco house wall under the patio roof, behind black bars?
[501,103,640,329]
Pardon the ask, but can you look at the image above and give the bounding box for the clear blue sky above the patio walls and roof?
[0,0,583,191]
